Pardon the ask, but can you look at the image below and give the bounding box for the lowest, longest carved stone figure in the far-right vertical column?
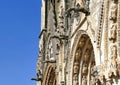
[109,45,117,76]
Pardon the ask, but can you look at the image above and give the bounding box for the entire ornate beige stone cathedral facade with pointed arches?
[34,0,120,85]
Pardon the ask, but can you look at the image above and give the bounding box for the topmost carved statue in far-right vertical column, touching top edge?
[110,0,117,23]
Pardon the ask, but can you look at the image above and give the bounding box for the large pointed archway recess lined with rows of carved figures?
[72,34,96,85]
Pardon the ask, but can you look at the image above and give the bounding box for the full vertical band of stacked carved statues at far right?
[108,0,118,77]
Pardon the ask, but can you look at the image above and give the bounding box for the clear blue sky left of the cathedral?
[0,0,41,85]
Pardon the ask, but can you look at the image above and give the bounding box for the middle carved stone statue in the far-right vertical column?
[109,24,117,41]
